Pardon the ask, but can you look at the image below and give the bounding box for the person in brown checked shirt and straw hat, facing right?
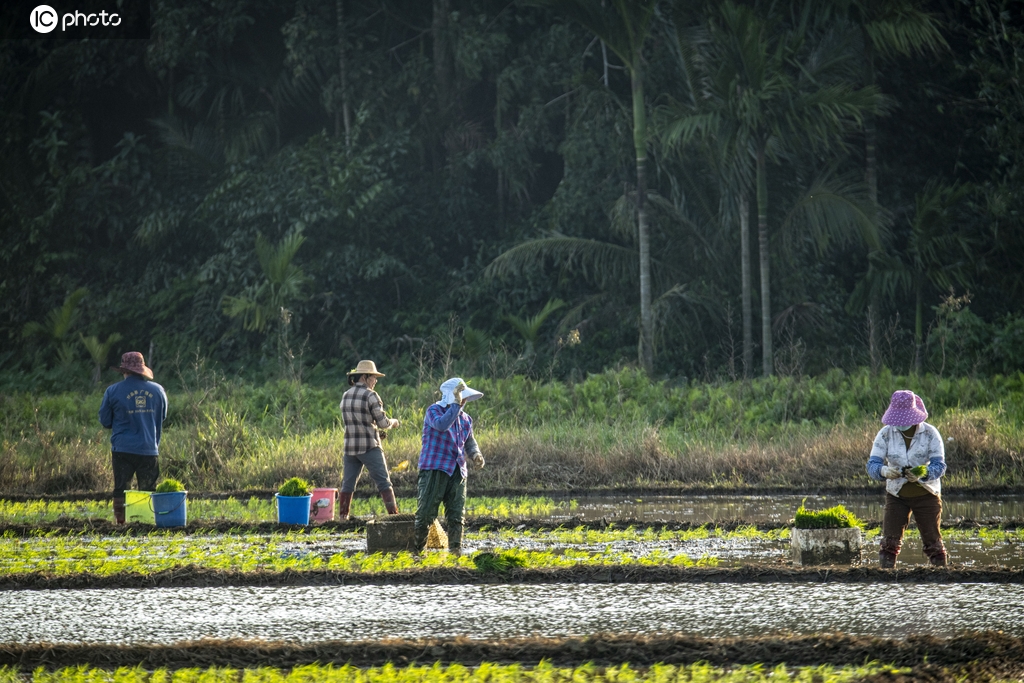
[338,360,399,520]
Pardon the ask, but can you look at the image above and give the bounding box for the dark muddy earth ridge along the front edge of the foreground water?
[0,633,1024,682]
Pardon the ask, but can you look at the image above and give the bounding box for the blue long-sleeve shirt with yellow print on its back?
[99,375,167,456]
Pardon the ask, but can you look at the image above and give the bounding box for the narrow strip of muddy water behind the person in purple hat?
[565,489,1024,523]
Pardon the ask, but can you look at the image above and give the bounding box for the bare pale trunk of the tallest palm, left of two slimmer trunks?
[631,64,654,375]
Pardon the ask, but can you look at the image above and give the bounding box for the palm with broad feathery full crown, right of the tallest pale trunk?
[664,0,881,376]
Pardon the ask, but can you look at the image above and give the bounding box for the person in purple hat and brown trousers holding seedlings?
[867,390,946,568]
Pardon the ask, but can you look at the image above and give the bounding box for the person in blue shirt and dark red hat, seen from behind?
[99,351,167,524]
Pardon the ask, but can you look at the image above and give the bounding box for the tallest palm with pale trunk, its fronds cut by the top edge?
[535,0,657,374]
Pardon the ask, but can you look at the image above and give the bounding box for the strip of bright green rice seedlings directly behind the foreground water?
[0,526,1024,577]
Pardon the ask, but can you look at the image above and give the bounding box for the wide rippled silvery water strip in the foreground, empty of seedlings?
[0,584,1024,644]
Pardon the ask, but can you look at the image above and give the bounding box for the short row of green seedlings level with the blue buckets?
[0,496,577,524]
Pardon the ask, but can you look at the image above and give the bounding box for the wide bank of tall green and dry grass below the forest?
[0,369,1024,494]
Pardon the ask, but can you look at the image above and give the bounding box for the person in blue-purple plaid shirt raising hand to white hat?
[416,377,483,554]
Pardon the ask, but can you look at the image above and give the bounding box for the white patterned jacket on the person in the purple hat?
[867,422,946,496]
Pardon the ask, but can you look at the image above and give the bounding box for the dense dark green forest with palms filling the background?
[0,0,1024,389]
